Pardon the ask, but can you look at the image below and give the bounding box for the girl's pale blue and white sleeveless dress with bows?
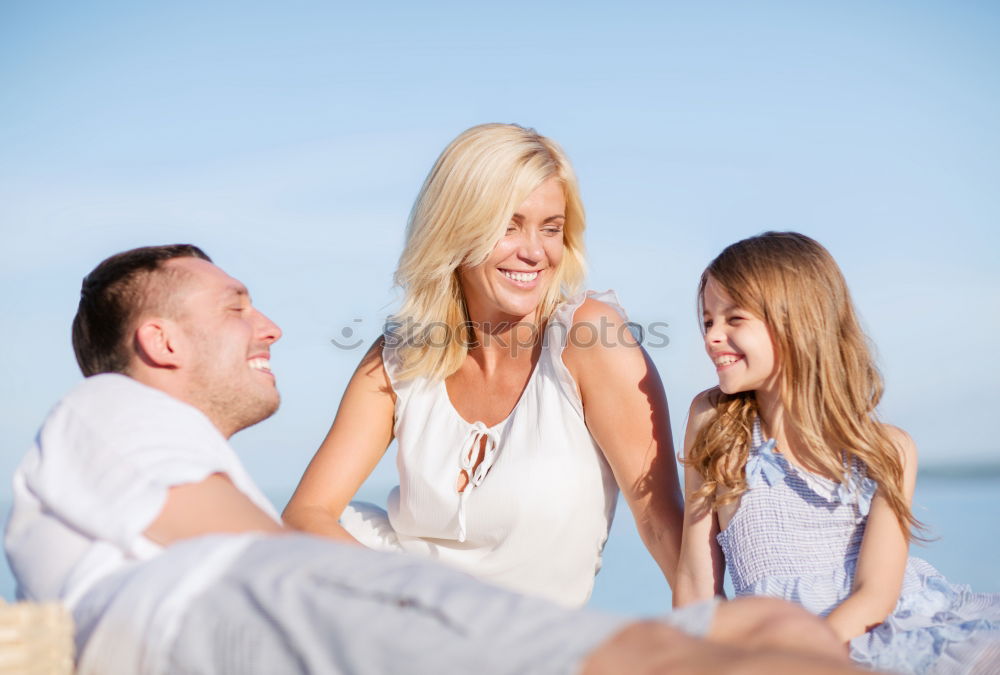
[718,420,1000,673]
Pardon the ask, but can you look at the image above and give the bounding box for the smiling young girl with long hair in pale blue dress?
[674,232,1000,673]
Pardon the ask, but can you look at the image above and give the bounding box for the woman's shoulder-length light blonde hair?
[386,124,585,379]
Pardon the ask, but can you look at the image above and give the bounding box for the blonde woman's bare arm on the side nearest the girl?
[563,299,684,587]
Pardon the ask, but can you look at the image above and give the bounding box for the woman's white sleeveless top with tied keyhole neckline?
[345,291,625,606]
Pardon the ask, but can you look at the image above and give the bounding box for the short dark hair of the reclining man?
[73,244,212,377]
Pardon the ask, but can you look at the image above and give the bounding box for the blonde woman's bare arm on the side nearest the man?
[282,338,395,542]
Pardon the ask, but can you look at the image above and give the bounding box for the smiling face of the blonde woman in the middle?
[459,177,566,322]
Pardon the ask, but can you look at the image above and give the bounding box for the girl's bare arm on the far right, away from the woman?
[826,425,917,642]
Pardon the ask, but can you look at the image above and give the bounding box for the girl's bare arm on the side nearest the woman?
[674,392,726,607]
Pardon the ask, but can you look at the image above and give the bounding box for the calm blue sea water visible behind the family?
[0,470,1000,615]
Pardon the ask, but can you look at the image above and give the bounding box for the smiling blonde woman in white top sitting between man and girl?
[284,124,683,606]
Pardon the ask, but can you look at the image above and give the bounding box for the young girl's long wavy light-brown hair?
[684,232,921,536]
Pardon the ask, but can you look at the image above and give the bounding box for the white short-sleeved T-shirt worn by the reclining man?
[4,374,280,675]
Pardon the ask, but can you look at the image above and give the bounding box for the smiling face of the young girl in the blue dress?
[702,277,778,394]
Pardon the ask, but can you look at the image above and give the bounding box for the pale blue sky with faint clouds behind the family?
[0,1,1000,506]
